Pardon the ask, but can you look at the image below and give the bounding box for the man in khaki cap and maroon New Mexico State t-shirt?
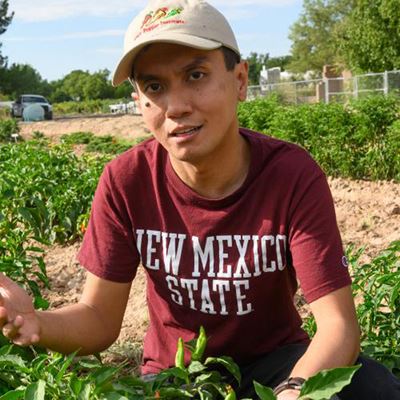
[0,0,400,400]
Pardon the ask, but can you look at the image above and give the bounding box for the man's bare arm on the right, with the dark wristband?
[279,286,360,399]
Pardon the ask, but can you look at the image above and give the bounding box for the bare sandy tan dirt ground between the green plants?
[21,115,400,362]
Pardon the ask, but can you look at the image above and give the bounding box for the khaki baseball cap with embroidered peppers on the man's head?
[112,0,240,86]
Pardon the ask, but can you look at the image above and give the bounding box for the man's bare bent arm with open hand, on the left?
[0,272,131,355]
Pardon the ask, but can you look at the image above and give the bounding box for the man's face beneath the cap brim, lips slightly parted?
[134,44,247,164]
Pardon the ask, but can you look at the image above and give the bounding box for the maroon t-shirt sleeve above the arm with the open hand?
[77,167,140,283]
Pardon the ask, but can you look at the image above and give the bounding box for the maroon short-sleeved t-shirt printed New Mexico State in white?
[78,129,350,373]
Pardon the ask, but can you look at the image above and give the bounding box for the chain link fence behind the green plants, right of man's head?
[247,70,400,104]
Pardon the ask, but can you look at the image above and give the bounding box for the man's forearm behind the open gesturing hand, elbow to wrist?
[37,303,118,355]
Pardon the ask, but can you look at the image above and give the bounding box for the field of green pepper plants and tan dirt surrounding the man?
[0,108,400,400]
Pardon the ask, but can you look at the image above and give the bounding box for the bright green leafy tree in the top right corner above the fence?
[338,0,400,73]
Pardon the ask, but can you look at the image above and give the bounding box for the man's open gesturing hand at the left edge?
[0,272,40,346]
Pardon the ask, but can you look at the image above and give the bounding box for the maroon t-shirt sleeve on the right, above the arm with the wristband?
[289,161,351,303]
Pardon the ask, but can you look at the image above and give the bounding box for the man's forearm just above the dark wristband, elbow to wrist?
[291,322,360,379]
